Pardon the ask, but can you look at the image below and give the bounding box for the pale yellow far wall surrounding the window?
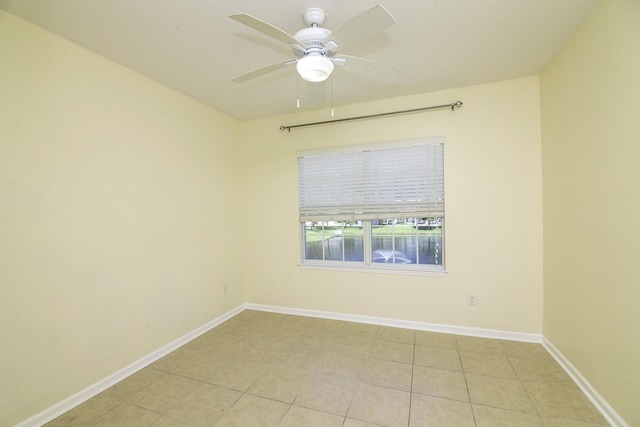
[242,77,542,333]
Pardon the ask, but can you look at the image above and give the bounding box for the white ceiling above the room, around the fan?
[0,0,599,120]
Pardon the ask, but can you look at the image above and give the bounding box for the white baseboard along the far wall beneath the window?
[244,303,542,343]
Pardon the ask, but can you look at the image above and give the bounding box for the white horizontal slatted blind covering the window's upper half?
[298,143,444,222]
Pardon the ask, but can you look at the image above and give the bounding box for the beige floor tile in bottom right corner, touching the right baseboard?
[524,382,607,425]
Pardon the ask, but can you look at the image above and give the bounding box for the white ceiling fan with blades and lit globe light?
[230,5,402,83]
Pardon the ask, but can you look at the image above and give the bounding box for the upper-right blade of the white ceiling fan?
[324,5,396,56]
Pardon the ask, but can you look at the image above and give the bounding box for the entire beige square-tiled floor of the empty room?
[48,310,608,427]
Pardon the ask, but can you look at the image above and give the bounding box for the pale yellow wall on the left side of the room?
[0,12,244,425]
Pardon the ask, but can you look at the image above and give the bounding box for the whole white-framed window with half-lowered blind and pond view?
[298,138,444,272]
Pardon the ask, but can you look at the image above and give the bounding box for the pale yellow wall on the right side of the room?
[541,0,640,426]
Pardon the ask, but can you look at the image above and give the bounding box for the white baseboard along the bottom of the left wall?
[14,305,245,427]
